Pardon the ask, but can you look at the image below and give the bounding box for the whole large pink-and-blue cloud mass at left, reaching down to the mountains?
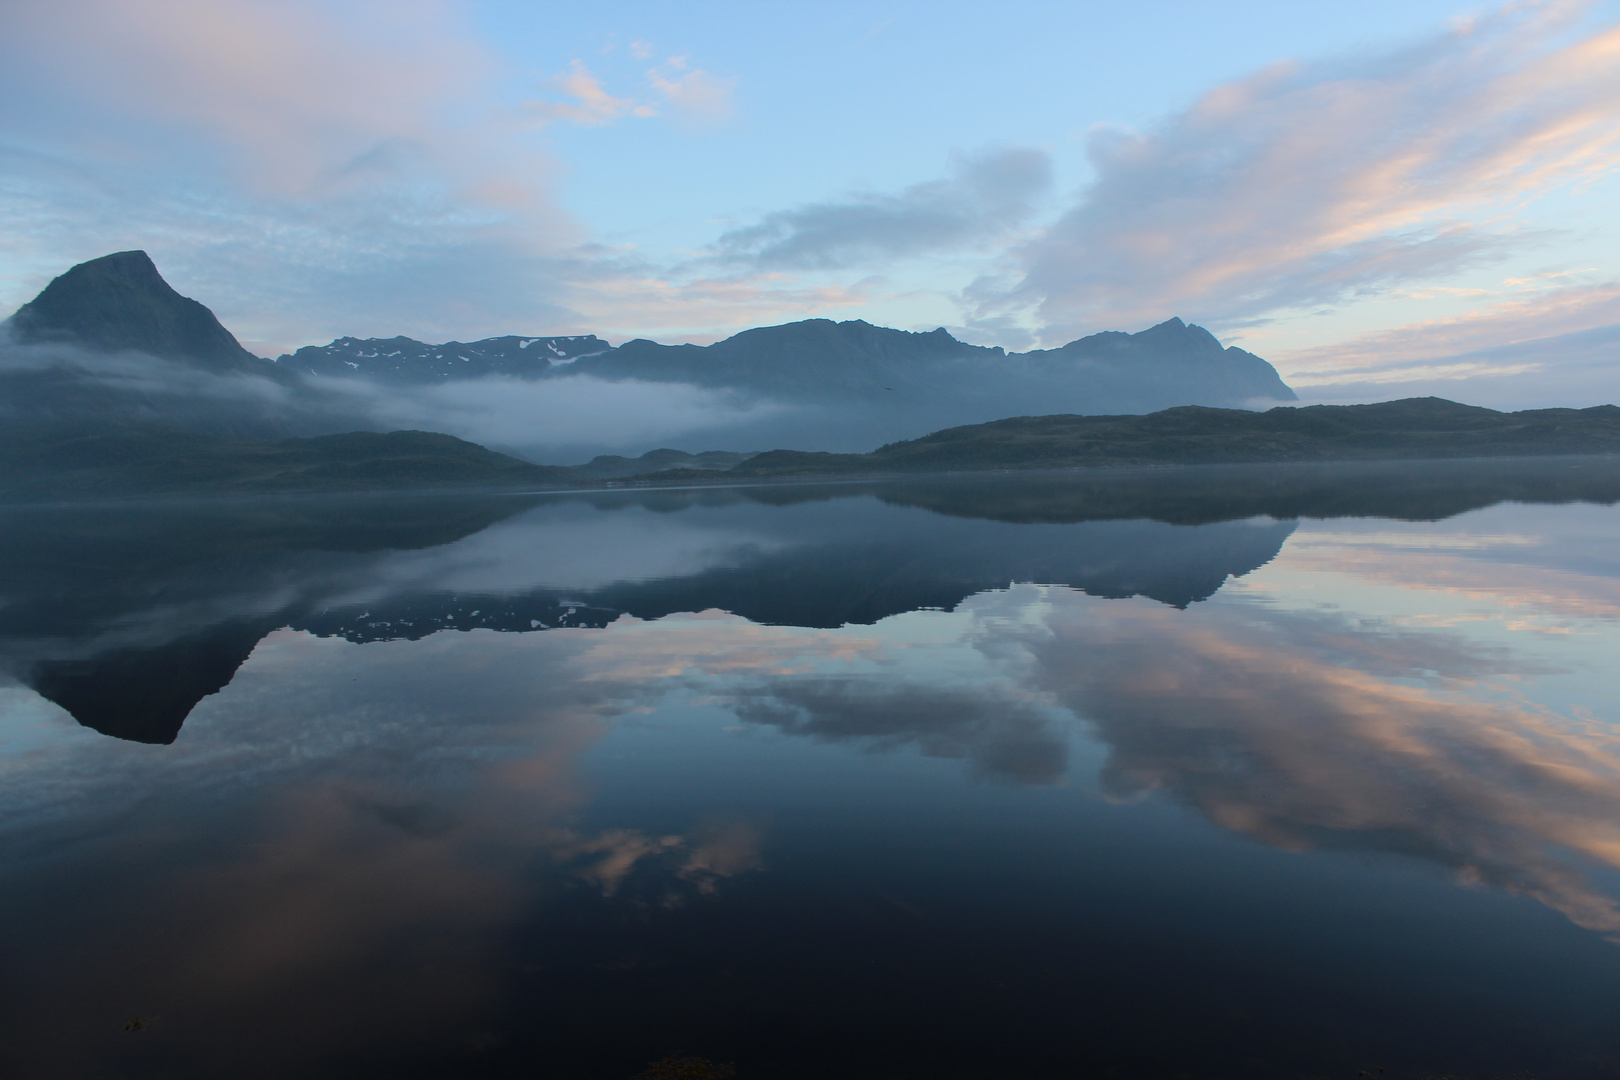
[0,0,601,351]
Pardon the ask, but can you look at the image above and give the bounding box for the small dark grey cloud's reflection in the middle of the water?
[732,677,1068,784]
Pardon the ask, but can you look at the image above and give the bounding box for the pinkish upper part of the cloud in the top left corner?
[0,0,492,198]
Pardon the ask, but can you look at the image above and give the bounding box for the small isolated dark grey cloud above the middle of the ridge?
[714,149,1051,270]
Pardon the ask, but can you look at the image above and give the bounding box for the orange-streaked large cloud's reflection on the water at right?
[1030,602,1620,941]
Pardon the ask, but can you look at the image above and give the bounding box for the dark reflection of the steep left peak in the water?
[0,495,544,743]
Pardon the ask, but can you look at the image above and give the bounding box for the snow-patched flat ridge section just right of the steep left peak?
[275,334,611,382]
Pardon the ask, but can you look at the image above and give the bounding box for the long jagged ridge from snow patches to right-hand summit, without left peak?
[275,319,1296,433]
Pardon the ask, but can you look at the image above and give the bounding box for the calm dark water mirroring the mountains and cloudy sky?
[0,460,1620,1080]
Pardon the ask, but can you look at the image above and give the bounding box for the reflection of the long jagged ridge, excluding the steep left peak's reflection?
[293,518,1293,641]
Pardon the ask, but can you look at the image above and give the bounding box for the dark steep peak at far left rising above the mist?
[10,251,271,374]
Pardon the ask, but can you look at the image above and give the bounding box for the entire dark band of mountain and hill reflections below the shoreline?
[9,461,1620,742]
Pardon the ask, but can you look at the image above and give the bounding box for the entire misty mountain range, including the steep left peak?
[0,251,1294,473]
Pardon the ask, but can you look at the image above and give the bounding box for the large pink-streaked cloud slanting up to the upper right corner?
[991,6,1620,338]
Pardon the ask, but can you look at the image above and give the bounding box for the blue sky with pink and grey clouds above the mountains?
[0,0,1620,408]
